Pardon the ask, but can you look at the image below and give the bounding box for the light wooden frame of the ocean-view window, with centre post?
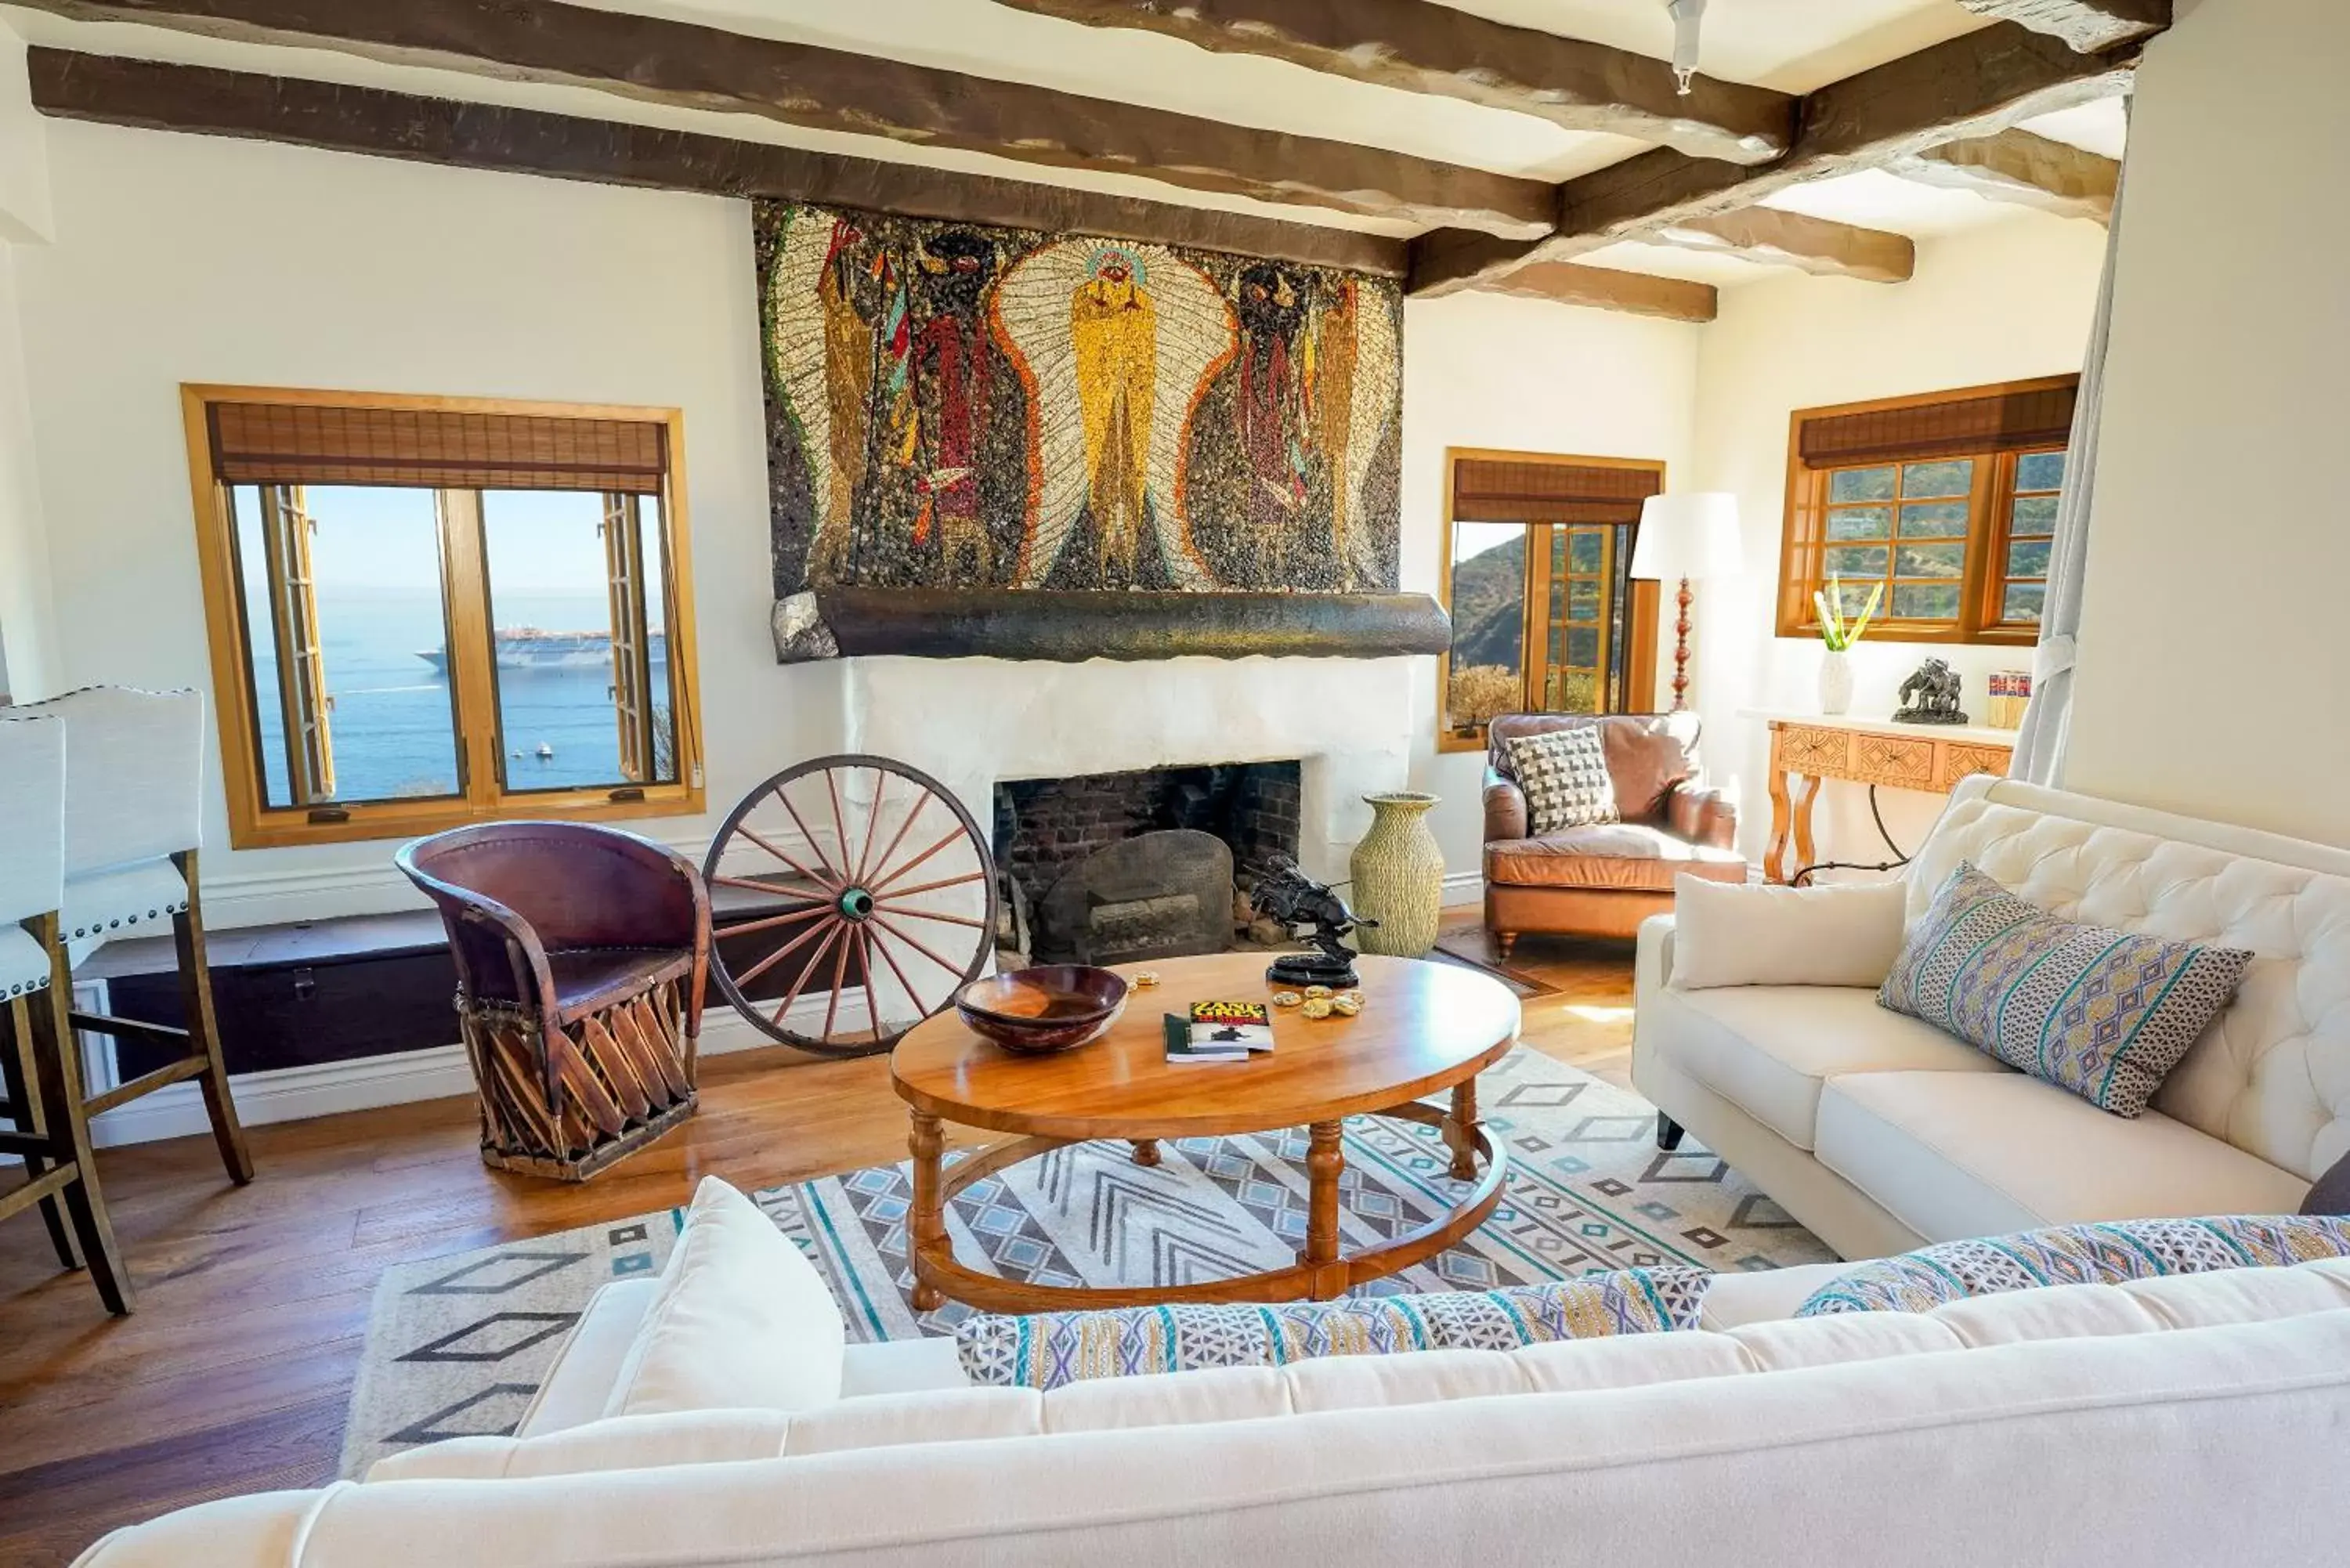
[181,383,705,849]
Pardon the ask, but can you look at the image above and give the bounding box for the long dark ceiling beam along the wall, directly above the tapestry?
[26,47,1403,277]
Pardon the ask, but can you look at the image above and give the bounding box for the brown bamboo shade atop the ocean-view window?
[209,402,667,496]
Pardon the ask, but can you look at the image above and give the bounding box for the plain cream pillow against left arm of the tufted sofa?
[1671,877,1908,990]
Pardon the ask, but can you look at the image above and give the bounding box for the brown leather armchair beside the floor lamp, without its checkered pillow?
[1485,712,1746,957]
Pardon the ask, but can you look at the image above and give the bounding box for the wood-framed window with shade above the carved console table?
[1779,376,2080,644]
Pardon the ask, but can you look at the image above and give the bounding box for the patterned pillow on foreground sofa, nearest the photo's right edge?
[1795,1216,2350,1317]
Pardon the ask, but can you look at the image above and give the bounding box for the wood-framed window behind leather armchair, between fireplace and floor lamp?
[1436,449,1664,750]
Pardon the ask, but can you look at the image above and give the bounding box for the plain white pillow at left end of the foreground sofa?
[604,1176,848,1415]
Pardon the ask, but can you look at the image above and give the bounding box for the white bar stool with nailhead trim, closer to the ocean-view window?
[12,686,254,1187]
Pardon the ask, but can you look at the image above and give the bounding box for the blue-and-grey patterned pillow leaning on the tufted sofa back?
[1878,861,2251,1117]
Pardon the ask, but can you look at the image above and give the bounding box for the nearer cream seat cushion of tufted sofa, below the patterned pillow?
[1817,1071,2308,1239]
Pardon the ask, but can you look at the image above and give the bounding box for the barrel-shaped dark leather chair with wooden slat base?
[397,823,710,1180]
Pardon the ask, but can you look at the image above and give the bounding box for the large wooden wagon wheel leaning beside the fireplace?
[703,757,996,1056]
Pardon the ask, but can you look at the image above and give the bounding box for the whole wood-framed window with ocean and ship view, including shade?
[183,385,703,849]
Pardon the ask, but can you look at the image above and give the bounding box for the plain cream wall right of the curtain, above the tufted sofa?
[2063,0,2350,844]
